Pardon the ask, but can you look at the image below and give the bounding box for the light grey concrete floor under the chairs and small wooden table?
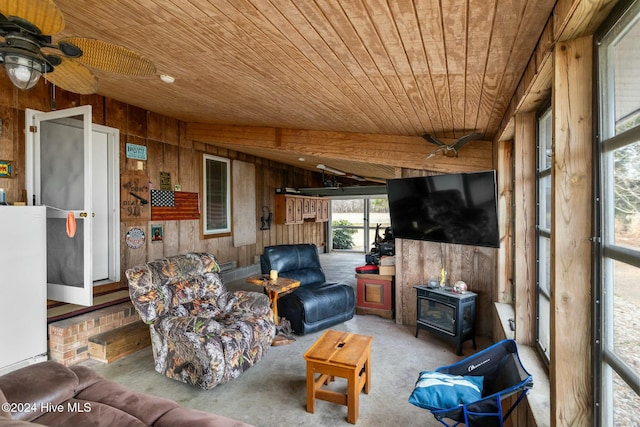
[83,252,489,427]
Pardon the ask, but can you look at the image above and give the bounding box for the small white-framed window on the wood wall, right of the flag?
[202,154,231,236]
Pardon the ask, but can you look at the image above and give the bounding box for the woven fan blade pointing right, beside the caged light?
[60,37,156,76]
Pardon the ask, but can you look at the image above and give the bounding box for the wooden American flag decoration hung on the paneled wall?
[151,190,200,221]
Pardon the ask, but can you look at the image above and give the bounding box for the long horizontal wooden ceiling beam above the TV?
[186,123,492,178]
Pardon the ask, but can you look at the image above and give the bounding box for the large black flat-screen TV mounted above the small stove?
[387,171,500,248]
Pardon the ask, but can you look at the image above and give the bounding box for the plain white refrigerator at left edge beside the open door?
[0,206,47,375]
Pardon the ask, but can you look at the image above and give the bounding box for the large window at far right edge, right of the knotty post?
[595,1,640,426]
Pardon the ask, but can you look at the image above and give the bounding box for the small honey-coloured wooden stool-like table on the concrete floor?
[304,329,373,424]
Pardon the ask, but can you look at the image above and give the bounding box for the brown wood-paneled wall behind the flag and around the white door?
[0,79,327,283]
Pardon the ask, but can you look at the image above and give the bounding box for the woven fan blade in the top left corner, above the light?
[0,0,64,35]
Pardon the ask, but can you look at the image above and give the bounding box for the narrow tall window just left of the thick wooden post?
[536,108,553,364]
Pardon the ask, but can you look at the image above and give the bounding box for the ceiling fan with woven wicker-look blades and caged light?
[0,0,155,95]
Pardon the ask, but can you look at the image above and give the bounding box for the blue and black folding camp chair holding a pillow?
[410,339,533,427]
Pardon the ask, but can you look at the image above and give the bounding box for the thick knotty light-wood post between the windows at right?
[549,36,593,427]
